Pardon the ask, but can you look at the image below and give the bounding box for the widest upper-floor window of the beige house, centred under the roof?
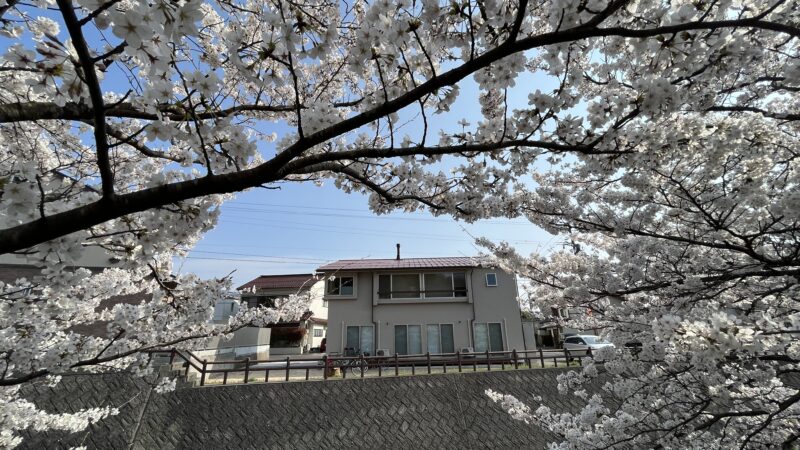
[378,272,467,299]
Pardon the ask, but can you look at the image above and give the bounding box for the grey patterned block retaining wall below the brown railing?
[21,369,600,450]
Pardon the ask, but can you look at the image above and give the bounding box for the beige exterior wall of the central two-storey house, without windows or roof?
[326,268,525,354]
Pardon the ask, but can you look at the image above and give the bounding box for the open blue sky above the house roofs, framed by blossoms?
[176,71,563,286]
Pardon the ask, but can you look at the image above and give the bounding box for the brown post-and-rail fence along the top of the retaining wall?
[150,349,592,386]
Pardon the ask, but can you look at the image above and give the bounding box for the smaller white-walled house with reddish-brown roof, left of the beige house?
[231,273,328,356]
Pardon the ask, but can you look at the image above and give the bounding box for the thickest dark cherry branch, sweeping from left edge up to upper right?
[0,16,800,254]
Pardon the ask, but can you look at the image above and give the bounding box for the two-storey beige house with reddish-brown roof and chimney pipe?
[317,256,525,355]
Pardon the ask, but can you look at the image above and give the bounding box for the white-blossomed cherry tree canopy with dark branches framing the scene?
[0,0,800,447]
